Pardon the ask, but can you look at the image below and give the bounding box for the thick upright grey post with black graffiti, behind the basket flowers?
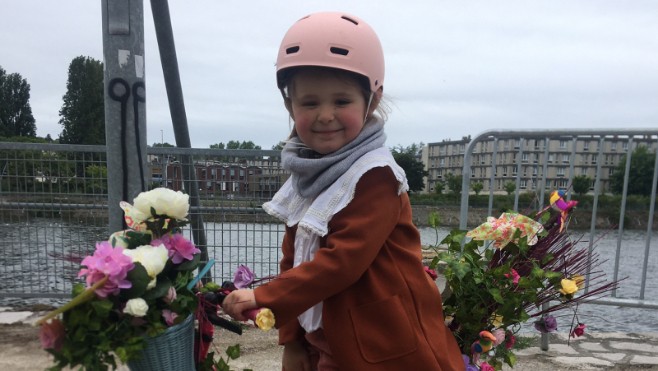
[101,0,147,233]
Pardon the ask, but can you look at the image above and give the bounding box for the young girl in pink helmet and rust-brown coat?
[223,13,464,371]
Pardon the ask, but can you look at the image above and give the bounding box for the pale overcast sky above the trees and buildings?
[0,0,658,149]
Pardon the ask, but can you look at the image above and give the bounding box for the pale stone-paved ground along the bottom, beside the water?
[0,308,658,371]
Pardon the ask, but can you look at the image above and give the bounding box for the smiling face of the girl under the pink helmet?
[288,70,376,155]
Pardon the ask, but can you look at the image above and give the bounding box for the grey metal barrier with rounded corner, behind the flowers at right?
[460,129,658,350]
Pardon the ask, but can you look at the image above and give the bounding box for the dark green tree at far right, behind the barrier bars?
[610,146,656,195]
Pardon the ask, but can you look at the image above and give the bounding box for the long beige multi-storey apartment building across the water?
[422,136,656,193]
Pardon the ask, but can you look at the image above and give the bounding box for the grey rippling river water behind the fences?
[0,219,658,332]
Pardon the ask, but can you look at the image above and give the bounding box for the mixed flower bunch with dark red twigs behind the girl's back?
[428,195,617,370]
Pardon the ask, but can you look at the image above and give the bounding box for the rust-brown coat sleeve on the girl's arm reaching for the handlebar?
[254,167,402,326]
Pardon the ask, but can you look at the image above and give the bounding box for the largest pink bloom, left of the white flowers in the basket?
[78,241,135,298]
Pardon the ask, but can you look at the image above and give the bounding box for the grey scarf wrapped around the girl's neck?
[281,119,386,198]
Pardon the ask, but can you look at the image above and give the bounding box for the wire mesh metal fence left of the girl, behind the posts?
[0,143,287,298]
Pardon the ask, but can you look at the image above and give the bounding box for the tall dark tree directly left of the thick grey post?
[59,56,105,144]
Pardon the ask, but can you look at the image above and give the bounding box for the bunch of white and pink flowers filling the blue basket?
[37,188,200,370]
